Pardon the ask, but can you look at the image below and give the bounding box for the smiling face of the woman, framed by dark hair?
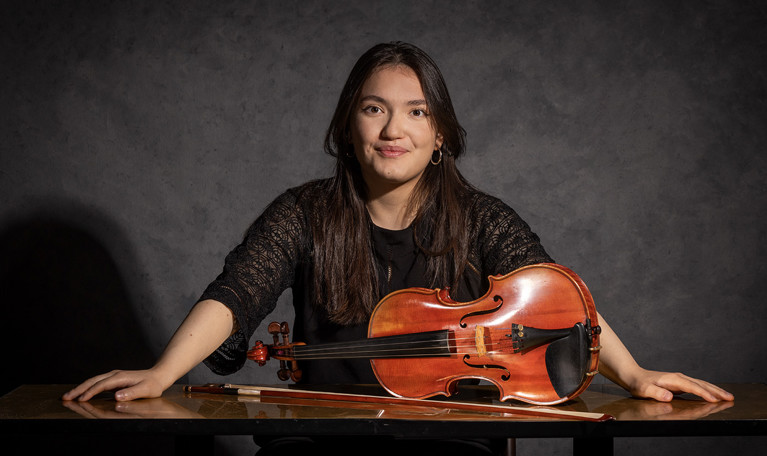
[351,65,442,193]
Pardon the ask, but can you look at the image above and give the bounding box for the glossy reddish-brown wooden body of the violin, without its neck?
[368,264,599,404]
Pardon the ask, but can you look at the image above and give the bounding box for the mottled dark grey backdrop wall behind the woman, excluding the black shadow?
[0,0,767,454]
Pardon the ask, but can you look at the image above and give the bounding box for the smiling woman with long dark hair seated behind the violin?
[63,43,733,408]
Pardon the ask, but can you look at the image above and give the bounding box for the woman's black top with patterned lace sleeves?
[200,182,552,384]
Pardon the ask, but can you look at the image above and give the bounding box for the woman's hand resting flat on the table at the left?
[61,369,173,401]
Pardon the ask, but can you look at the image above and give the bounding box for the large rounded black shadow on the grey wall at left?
[0,211,156,394]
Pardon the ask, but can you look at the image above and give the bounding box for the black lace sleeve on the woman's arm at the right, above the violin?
[474,195,554,275]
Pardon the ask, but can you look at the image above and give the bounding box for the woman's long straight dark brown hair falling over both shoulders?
[313,42,470,325]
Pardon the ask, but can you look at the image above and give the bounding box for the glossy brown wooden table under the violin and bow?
[0,384,767,455]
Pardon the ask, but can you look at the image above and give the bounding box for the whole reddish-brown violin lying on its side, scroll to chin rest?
[247,263,601,405]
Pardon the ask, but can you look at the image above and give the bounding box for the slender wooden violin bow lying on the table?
[184,383,615,422]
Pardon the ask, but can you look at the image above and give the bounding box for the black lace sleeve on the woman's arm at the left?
[200,191,308,375]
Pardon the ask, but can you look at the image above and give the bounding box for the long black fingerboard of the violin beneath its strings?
[292,329,455,360]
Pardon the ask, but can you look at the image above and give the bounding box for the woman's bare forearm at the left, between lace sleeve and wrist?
[151,299,234,388]
